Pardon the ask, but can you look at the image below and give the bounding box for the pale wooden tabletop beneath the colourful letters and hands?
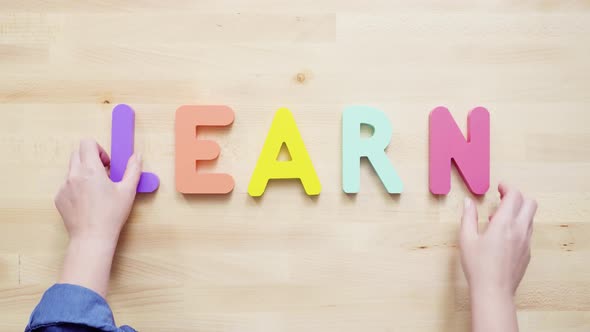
[0,0,590,332]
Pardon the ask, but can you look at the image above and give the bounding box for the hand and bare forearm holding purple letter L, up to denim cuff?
[55,140,141,297]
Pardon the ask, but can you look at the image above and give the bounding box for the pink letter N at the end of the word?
[429,107,490,195]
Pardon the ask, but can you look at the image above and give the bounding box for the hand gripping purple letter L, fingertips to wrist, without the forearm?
[55,140,141,244]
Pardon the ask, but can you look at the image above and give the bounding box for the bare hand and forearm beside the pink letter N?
[459,184,537,332]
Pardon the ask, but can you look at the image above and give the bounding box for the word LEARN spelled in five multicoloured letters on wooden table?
[110,104,490,197]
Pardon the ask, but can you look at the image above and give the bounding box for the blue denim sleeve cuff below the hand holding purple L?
[25,284,135,332]
